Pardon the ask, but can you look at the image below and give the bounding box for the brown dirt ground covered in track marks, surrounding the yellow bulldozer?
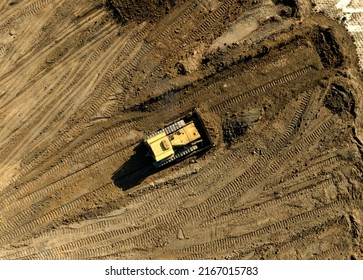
[0,0,363,259]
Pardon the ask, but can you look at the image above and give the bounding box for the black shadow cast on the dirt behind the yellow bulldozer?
[112,143,156,191]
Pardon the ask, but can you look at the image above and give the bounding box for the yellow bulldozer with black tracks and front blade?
[144,109,213,167]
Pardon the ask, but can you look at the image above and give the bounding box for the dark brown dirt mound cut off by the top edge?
[107,0,185,22]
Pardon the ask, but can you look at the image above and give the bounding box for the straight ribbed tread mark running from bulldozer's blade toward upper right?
[212,65,314,113]
